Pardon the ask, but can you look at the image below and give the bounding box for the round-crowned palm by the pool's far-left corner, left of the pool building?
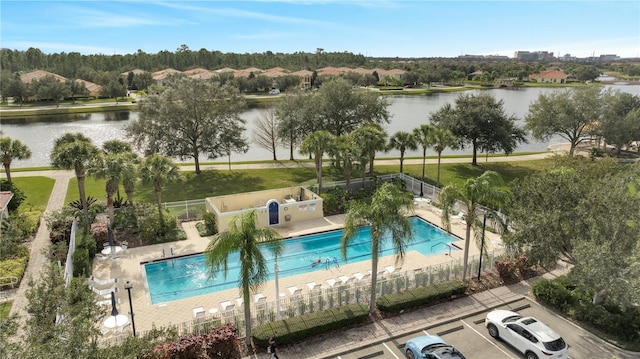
[140,154,181,226]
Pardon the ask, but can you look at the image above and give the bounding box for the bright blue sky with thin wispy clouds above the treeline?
[0,0,640,57]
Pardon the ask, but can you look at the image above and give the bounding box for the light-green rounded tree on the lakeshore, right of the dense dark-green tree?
[525,86,602,156]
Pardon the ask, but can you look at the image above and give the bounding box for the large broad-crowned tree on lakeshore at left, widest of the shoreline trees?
[127,77,246,174]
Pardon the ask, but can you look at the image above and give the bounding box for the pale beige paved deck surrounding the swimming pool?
[93,205,501,338]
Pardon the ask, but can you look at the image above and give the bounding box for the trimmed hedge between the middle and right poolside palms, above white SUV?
[376,280,467,313]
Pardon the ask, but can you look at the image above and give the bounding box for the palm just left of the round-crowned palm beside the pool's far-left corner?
[87,155,126,229]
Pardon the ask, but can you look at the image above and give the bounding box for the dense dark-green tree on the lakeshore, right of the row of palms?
[431,93,525,166]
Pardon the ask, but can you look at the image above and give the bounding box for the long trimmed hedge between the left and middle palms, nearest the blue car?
[251,304,369,348]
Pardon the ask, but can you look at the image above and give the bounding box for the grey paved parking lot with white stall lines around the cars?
[324,298,637,359]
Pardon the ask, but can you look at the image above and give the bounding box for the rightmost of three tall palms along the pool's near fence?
[440,171,509,280]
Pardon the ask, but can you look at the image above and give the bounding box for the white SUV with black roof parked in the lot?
[484,310,569,359]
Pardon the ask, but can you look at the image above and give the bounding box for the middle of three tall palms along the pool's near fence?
[340,182,413,313]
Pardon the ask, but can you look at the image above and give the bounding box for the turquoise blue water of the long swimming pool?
[143,217,458,304]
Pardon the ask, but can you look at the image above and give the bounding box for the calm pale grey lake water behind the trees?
[0,85,640,168]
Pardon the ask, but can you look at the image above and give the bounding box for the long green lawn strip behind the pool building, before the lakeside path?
[65,161,545,203]
